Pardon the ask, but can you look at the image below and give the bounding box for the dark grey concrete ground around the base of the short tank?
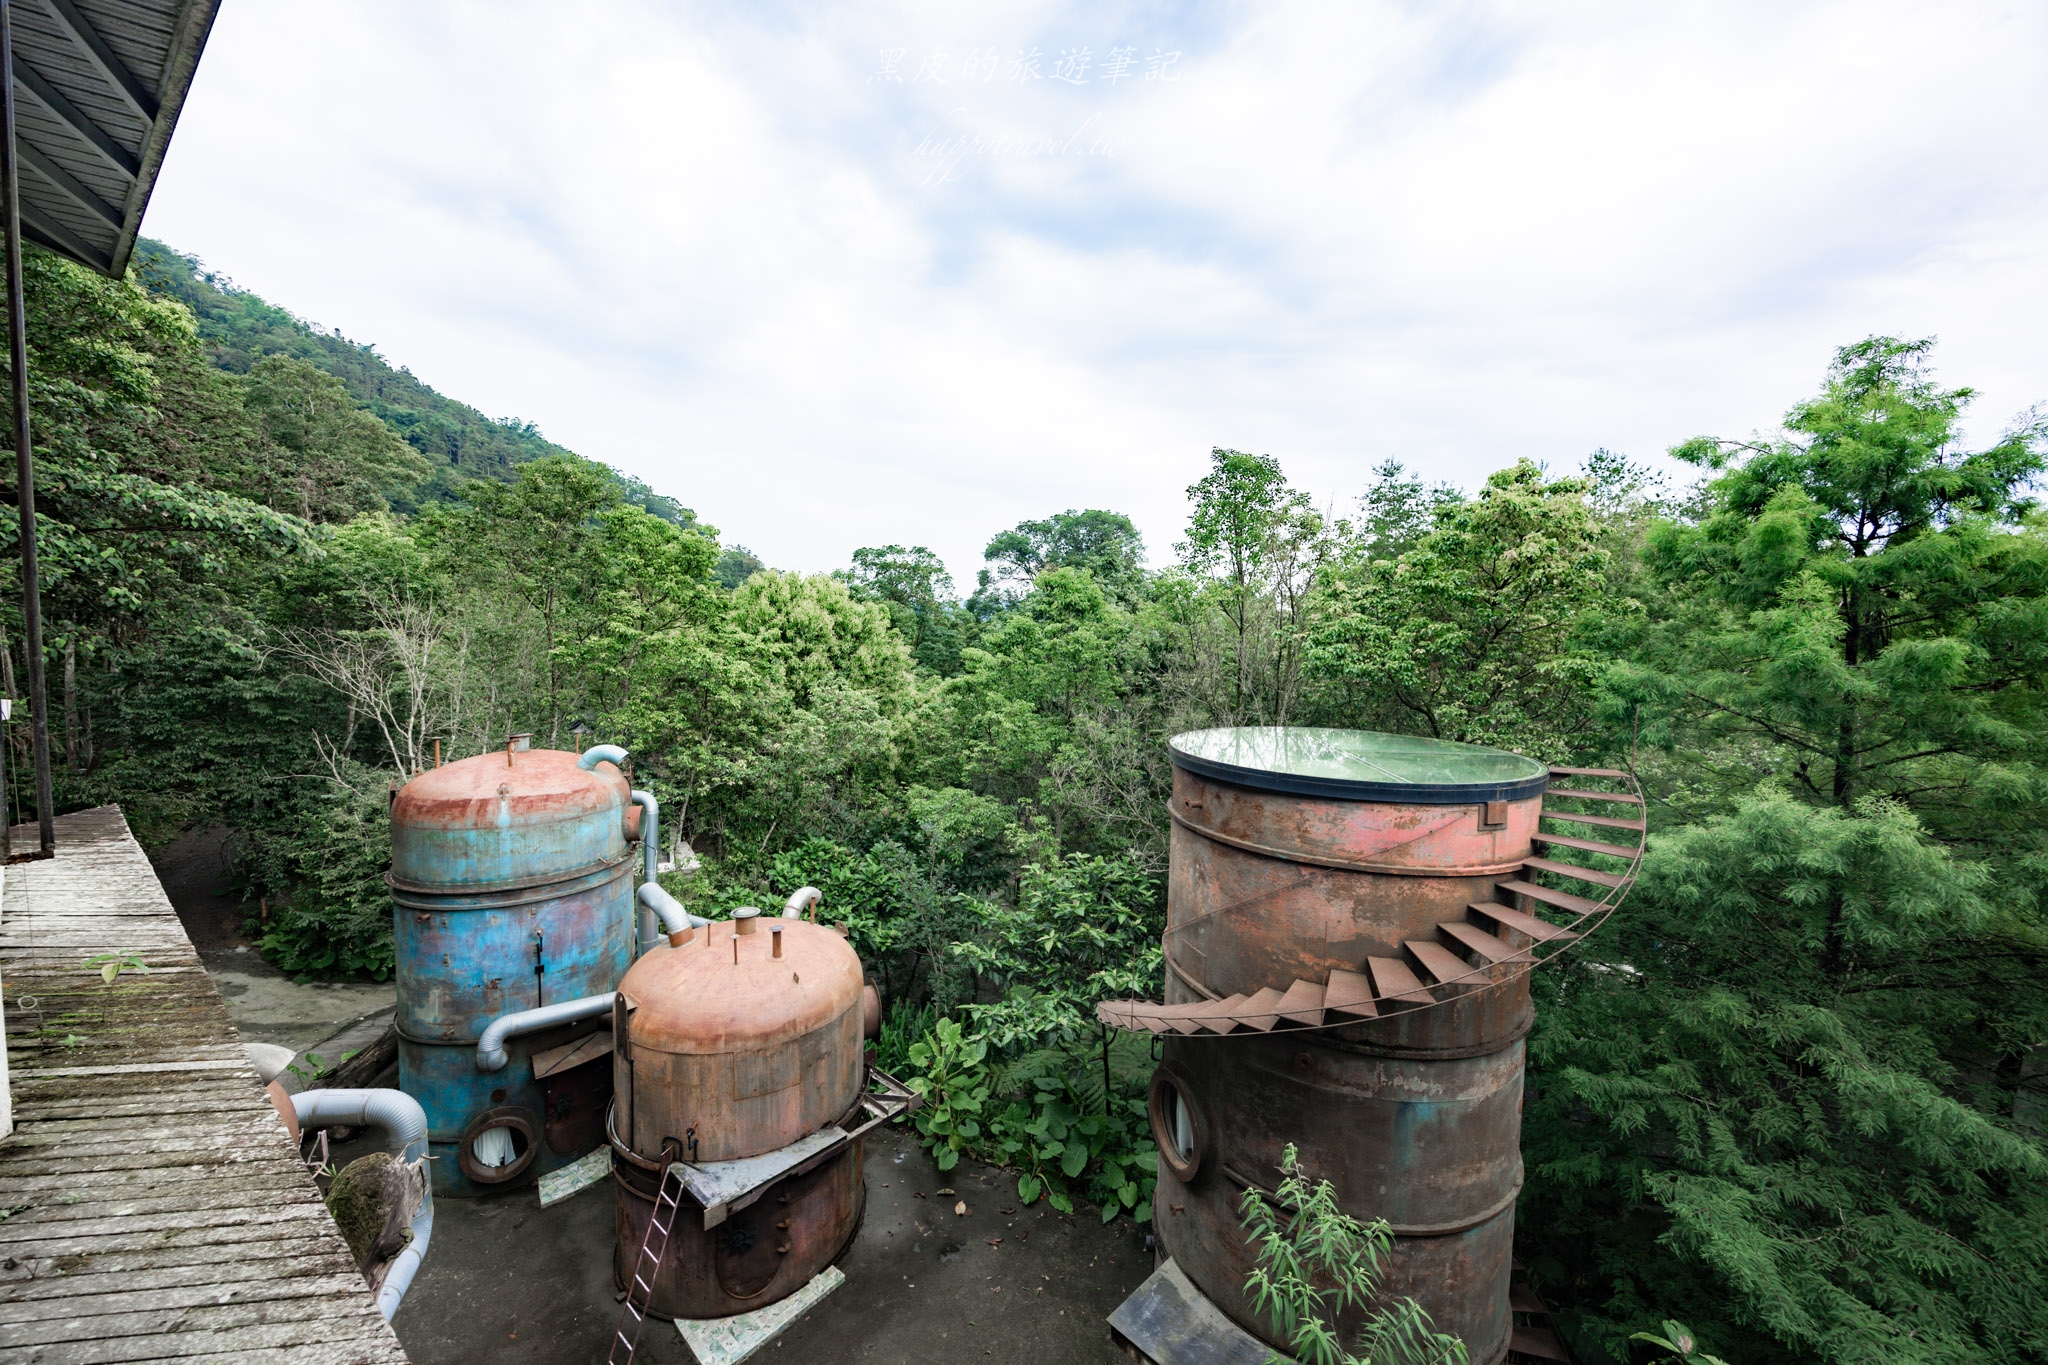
[385,1128,1153,1365]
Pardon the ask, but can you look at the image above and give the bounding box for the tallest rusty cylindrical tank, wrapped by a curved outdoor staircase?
[1151,726,1548,1365]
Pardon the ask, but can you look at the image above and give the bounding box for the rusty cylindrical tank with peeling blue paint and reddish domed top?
[391,747,639,1197]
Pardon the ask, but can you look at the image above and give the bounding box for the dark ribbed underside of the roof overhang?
[8,0,219,276]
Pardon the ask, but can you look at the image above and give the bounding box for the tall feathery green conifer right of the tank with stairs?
[1524,338,2048,1363]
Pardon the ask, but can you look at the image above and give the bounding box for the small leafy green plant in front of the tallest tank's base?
[1239,1142,1464,1365]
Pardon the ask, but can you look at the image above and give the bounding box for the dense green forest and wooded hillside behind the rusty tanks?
[0,246,2048,1365]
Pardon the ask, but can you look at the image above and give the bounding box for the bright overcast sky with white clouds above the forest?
[143,0,2048,589]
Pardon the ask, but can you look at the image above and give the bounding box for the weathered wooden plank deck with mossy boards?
[0,806,406,1365]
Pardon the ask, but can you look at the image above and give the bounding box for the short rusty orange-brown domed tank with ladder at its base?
[610,919,866,1318]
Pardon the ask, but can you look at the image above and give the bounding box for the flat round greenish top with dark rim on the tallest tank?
[1167,724,1550,806]
